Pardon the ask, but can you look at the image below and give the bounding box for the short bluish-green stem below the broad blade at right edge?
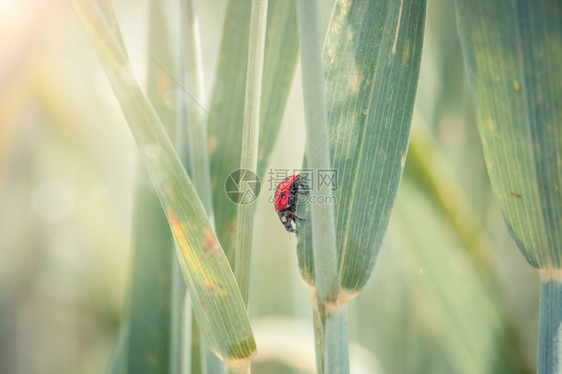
[537,274,562,374]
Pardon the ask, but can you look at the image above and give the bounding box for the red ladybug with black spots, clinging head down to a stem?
[273,174,308,232]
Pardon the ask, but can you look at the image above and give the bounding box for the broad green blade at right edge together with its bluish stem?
[456,0,562,373]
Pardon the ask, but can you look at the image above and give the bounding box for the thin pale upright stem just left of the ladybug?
[234,0,267,307]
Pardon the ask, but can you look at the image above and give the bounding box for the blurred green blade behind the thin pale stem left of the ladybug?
[208,0,298,263]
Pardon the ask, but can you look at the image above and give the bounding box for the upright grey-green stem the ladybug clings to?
[296,1,349,374]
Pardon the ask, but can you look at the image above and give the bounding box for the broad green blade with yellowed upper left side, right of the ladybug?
[298,0,425,296]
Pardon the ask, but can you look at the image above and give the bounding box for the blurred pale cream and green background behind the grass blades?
[0,0,538,374]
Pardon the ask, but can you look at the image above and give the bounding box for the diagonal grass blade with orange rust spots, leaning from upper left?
[73,1,255,368]
